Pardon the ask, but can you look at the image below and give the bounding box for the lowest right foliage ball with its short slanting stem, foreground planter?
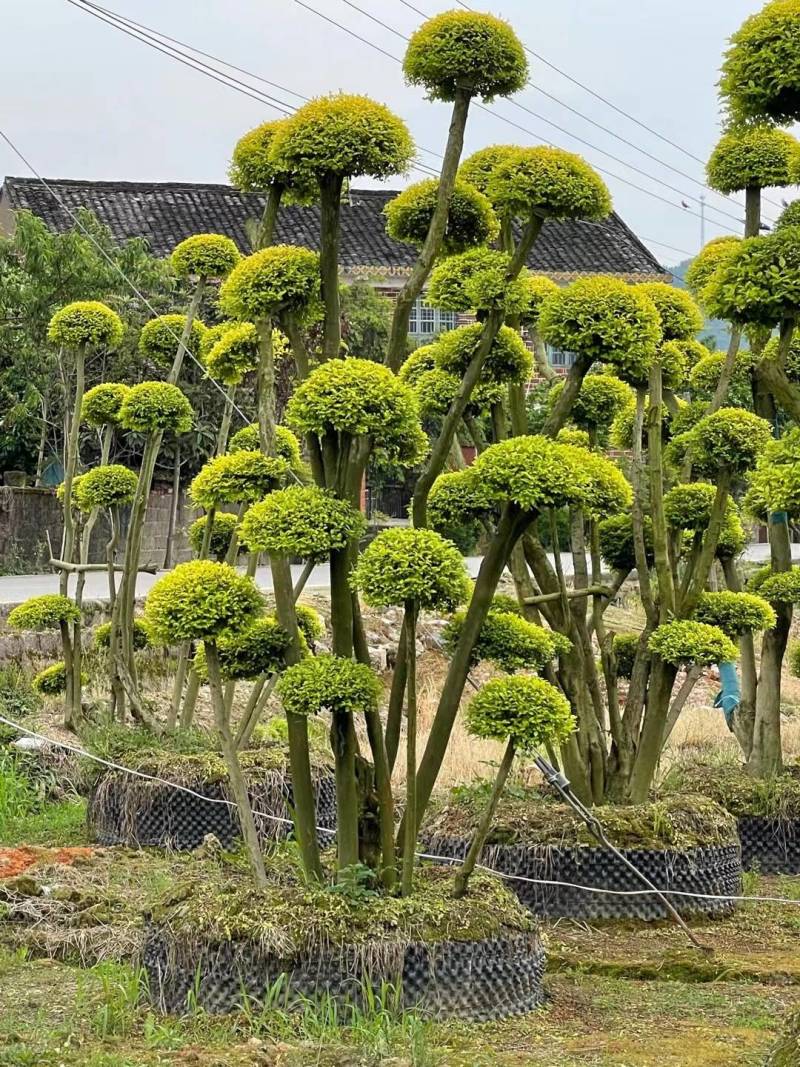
[453,675,575,898]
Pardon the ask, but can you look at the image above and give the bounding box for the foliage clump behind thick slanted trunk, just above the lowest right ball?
[442,608,571,674]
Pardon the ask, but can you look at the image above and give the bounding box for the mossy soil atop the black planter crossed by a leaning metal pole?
[426,783,737,849]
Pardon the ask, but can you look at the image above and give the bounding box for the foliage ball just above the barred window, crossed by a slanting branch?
[427,249,530,315]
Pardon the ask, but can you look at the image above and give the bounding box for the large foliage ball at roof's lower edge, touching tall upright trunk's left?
[220,244,320,322]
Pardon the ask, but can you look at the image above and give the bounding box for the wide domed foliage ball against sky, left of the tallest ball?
[271,93,414,184]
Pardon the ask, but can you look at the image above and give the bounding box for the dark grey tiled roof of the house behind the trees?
[2,177,665,277]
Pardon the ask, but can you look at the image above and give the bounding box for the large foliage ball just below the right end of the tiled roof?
[539,276,661,384]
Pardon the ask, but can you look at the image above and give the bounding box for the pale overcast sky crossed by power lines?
[0,0,796,264]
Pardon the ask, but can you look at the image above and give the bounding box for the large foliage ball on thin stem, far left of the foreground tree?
[144,559,263,644]
